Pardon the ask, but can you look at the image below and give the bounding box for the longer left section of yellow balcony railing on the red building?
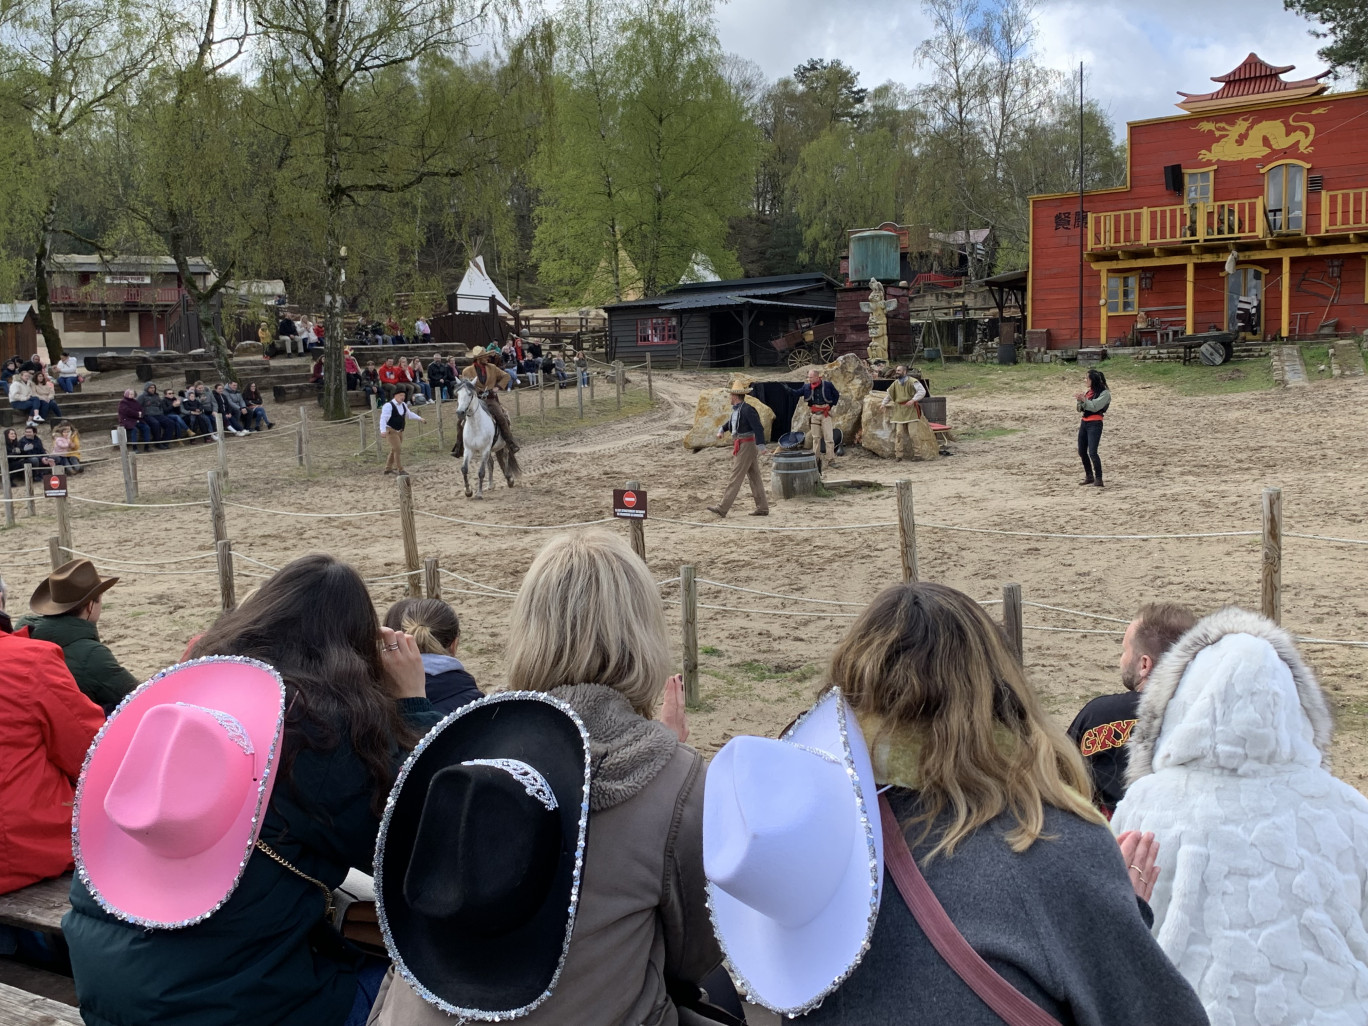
[1088,190,1269,250]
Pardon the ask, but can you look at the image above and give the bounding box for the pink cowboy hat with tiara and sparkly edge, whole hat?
[71,655,285,929]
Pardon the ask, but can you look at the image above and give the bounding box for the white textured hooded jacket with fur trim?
[1112,609,1368,1026]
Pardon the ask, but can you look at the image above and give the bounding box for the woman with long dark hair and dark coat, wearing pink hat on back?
[63,554,439,1026]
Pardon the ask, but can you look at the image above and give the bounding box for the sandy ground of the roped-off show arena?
[0,368,1368,792]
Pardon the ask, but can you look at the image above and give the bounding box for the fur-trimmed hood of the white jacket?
[1126,606,1332,785]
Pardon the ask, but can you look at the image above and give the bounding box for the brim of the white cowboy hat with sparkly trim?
[703,688,884,1016]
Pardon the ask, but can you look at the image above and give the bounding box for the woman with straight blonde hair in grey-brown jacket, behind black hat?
[372,531,721,1026]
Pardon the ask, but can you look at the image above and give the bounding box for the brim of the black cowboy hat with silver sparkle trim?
[375,691,590,1021]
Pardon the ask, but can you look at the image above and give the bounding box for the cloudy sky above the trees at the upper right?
[717,0,1324,127]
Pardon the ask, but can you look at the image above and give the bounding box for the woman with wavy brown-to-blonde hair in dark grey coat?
[804,584,1207,1026]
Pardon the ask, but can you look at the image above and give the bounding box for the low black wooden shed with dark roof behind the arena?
[605,271,836,369]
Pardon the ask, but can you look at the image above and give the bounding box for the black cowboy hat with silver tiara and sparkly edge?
[375,691,590,1019]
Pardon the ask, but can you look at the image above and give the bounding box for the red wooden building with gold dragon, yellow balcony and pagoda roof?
[1026,53,1368,349]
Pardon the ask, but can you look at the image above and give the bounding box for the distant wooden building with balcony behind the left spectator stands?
[48,253,213,349]
